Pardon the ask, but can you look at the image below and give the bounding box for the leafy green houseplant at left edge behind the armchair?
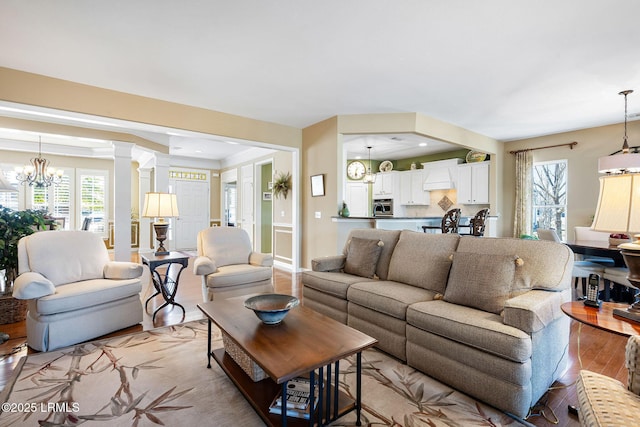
[0,205,54,290]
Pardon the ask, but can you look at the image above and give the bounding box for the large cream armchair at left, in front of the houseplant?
[13,231,144,351]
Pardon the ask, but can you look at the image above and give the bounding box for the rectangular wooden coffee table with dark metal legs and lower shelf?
[198,300,377,426]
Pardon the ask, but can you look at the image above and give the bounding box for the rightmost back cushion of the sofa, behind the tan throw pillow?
[457,236,574,296]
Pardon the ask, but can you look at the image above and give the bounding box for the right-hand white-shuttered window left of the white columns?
[76,169,109,235]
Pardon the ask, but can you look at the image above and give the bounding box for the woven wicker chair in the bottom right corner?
[576,335,640,427]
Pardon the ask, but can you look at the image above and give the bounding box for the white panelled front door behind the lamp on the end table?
[175,181,210,250]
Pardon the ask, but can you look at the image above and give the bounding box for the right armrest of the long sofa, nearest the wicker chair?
[503,290,570,334]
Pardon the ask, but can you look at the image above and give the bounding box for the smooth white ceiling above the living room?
[0,0,640,161]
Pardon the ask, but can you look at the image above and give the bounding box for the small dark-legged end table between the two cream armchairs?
[140,252,189,322]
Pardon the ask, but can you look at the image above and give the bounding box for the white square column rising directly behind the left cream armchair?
[112,141,133,261]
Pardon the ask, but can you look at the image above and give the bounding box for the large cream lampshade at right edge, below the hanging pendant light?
[591,173,640,233]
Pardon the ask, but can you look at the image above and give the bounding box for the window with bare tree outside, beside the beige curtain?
[532,160,567,240]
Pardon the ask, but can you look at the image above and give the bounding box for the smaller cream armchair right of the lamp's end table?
[193,227,273,301]
